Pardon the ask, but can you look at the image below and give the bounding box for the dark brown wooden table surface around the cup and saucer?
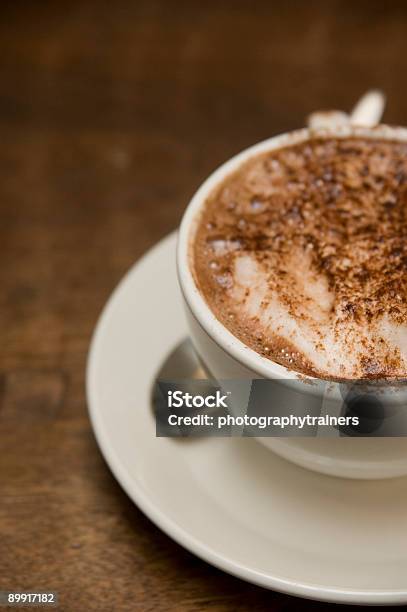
[0,0,407,612]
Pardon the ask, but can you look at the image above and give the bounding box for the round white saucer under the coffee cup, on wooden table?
[87,234,407,604]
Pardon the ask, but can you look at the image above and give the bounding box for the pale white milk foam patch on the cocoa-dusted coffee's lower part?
[230,253,407,378]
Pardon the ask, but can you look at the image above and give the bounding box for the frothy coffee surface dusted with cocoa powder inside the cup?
[191,137,407,379]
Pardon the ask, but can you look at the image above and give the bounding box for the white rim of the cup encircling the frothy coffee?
[177,123,407,384]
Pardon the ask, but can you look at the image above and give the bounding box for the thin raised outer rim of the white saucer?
[86,231,407,605]
